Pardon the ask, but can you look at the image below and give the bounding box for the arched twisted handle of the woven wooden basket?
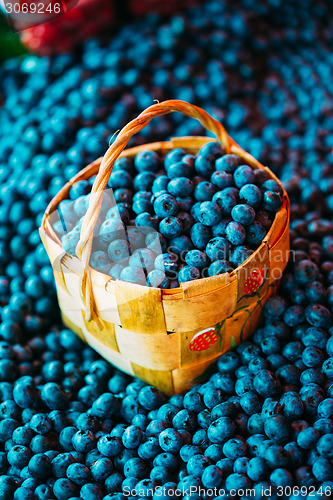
[76,99,235,321]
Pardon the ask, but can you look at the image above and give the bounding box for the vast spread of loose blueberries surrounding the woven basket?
[0,0,333,500]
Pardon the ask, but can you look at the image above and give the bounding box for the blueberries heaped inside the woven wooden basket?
[55,142,283,288]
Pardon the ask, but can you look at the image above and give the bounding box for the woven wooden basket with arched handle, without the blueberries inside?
[40,100,289,394]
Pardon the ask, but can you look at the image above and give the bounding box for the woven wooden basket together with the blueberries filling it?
[40,100,289,394]
